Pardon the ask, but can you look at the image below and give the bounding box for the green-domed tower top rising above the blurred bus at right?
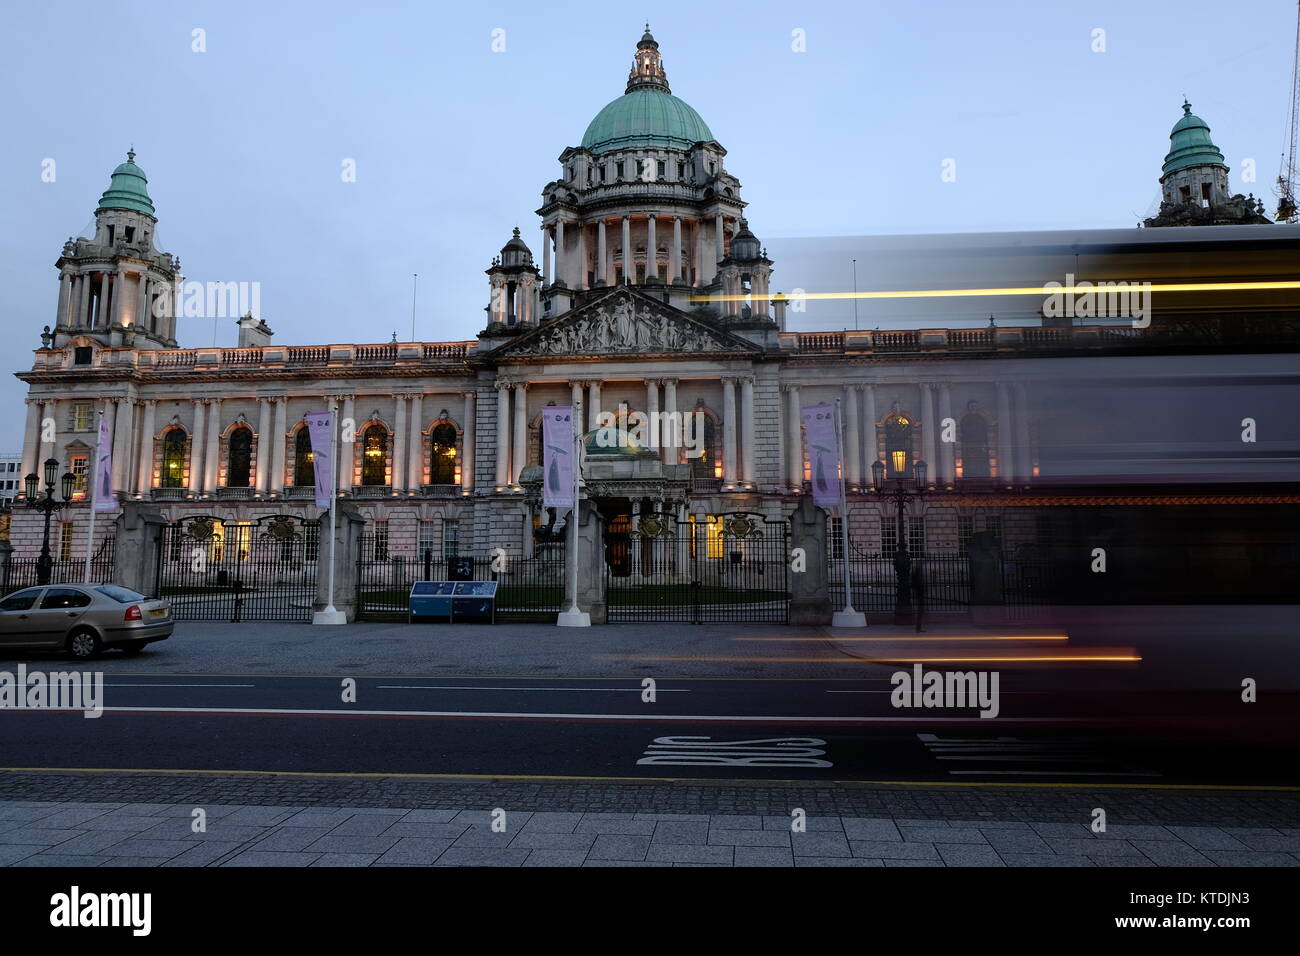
[1145,100,1269,226]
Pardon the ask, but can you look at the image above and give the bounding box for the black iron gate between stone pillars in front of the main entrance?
[605,511,790,624]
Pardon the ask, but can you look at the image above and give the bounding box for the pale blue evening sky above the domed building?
[0,0,1296,450]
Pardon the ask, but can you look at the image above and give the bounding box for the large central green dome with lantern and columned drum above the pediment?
[537,23,775,325]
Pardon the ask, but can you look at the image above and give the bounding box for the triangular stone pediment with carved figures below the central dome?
[493,289,759,359]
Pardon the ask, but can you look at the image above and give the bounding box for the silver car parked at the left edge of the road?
[0,584,174,661]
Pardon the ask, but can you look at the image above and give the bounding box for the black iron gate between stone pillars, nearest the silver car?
[157,515,322,622]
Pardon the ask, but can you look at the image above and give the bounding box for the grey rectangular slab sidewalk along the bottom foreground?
[0,801,1300,866]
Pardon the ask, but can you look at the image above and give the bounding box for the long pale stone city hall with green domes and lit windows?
[7,29,1300,622]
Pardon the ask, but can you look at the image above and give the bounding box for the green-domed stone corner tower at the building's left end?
[44,150,182,349]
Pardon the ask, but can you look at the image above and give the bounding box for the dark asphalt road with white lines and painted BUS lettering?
[0,662,1300,786]
